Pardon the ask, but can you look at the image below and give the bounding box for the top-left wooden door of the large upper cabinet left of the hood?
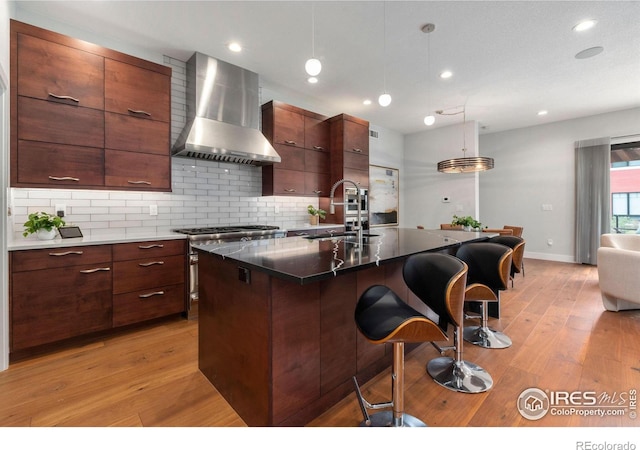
[17,33,104,109]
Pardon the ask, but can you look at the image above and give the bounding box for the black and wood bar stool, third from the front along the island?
[456,244,513,348]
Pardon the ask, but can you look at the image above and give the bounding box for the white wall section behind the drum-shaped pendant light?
[400,121,478,228]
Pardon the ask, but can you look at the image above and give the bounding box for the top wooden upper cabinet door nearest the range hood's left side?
[104,59,171,122]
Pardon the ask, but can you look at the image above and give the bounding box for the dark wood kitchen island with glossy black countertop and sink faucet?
[195,228,491,426]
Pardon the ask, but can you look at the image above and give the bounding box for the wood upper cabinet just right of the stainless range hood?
[262,101,330,197]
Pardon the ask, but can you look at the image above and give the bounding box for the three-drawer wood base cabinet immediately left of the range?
[113,240,188,327]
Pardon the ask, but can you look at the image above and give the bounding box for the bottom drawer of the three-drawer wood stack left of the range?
[113,284,185,327]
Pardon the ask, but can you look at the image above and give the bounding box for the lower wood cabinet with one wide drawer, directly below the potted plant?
[9,245,113,352]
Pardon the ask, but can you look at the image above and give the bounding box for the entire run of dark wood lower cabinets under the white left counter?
[9,239,188,355]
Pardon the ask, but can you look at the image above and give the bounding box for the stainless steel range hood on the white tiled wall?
[172,52,280,166]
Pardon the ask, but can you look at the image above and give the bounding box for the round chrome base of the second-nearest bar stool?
[427,356,493,394]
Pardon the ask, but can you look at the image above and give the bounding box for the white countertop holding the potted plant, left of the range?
[7,230,187,251]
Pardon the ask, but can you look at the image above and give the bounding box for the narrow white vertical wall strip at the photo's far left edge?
[0,0,13,370]
